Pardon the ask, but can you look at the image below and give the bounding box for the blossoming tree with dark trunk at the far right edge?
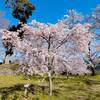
[87,5,100,75]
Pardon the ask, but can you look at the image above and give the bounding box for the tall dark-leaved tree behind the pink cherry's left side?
[4,0,35,63]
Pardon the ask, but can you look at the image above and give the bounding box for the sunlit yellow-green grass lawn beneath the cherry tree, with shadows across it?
[0,75,100,100]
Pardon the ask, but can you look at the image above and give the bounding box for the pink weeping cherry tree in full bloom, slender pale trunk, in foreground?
[2,17,91,95]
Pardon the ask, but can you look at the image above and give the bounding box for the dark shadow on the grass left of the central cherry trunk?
[0,84,49,100]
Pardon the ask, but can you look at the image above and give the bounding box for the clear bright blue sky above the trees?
[0,0,100,60]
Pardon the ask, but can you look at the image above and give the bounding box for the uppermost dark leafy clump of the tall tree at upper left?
[5,0,35,23]
